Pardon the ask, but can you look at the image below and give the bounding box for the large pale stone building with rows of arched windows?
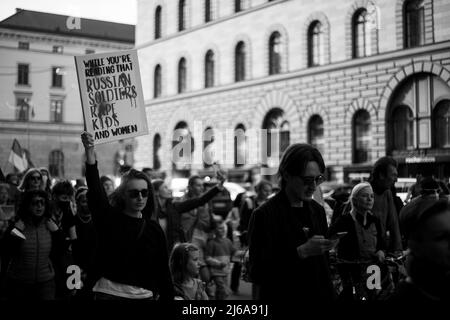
[135,0,450,180]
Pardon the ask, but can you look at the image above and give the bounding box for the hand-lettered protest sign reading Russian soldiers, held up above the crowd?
[75,50,148,144]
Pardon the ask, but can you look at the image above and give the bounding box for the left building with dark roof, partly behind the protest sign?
[0,9,135,179]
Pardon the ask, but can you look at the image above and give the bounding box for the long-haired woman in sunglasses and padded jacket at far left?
[3,190,64,300]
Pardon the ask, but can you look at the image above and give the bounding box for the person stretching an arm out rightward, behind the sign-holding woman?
[152,175,225,252]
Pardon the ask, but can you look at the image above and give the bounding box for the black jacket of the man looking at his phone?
[249,191,334,302]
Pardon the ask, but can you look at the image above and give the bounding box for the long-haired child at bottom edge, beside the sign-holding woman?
[169,243,208,300]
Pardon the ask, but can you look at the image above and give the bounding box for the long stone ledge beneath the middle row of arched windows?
[145,41,450,107]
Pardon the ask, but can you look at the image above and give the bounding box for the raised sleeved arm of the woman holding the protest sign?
[81,132,111,224]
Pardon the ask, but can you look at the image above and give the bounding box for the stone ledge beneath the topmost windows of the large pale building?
[136,0,291,49]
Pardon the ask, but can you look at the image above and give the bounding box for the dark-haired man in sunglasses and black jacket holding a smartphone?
[249,144,338,302]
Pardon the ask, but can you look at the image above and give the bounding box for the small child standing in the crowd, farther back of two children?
[205,221,243,300]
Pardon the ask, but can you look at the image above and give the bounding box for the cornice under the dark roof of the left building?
[0,28,134,52]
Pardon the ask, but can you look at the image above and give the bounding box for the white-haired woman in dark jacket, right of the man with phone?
[329,182,385,297]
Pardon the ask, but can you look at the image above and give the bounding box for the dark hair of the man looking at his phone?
[278,143,325,189]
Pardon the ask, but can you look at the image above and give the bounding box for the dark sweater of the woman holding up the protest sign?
[86,163,173,300]
